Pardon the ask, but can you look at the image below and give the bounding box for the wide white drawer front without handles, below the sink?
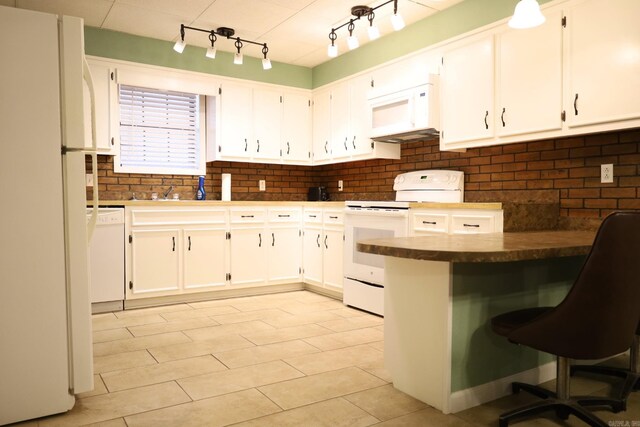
[131,209,227,227]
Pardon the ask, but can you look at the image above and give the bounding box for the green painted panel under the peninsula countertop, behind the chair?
[451,257,584,392]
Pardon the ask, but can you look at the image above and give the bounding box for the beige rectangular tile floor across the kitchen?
[13,291,640,427]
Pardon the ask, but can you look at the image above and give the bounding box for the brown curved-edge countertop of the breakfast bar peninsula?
[358,231,596,262]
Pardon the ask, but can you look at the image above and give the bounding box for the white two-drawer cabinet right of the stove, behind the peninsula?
[409,208,504,236]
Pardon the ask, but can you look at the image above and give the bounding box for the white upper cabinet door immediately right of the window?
[218,83,253,159]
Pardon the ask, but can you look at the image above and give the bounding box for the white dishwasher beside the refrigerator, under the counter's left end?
[87,208,125,313]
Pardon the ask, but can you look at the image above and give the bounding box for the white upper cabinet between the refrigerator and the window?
[84,59,119,155]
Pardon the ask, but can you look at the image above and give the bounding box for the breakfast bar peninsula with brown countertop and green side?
[357,231,595,414]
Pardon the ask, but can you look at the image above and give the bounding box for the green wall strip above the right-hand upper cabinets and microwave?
[313,0,551,88]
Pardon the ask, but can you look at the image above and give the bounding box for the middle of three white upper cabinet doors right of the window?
[249,88,282,160]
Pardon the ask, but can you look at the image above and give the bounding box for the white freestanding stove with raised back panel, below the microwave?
[343,170,464,316]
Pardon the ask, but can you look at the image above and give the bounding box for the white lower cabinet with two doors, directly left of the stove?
[303,208,344,292]
